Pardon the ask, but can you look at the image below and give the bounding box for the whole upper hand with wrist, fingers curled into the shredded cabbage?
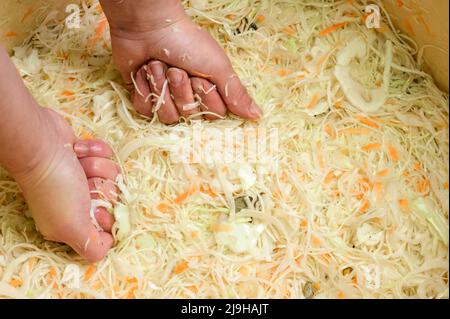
[101,0,262,124]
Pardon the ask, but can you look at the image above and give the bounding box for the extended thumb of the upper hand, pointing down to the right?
[211,63,262,120]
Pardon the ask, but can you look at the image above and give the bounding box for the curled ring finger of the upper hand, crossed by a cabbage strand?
[147,61,180,124]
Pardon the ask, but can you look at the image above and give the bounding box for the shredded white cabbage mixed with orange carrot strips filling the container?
[0,0,449,298]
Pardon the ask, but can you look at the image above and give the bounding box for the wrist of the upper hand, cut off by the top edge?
[100,0,185,33]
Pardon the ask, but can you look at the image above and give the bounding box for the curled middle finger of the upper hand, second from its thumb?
[167,68,200,117]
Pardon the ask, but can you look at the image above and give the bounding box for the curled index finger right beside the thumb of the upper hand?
[191,78,227,120]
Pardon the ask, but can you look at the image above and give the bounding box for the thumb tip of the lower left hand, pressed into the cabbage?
[65,222,114,263]
